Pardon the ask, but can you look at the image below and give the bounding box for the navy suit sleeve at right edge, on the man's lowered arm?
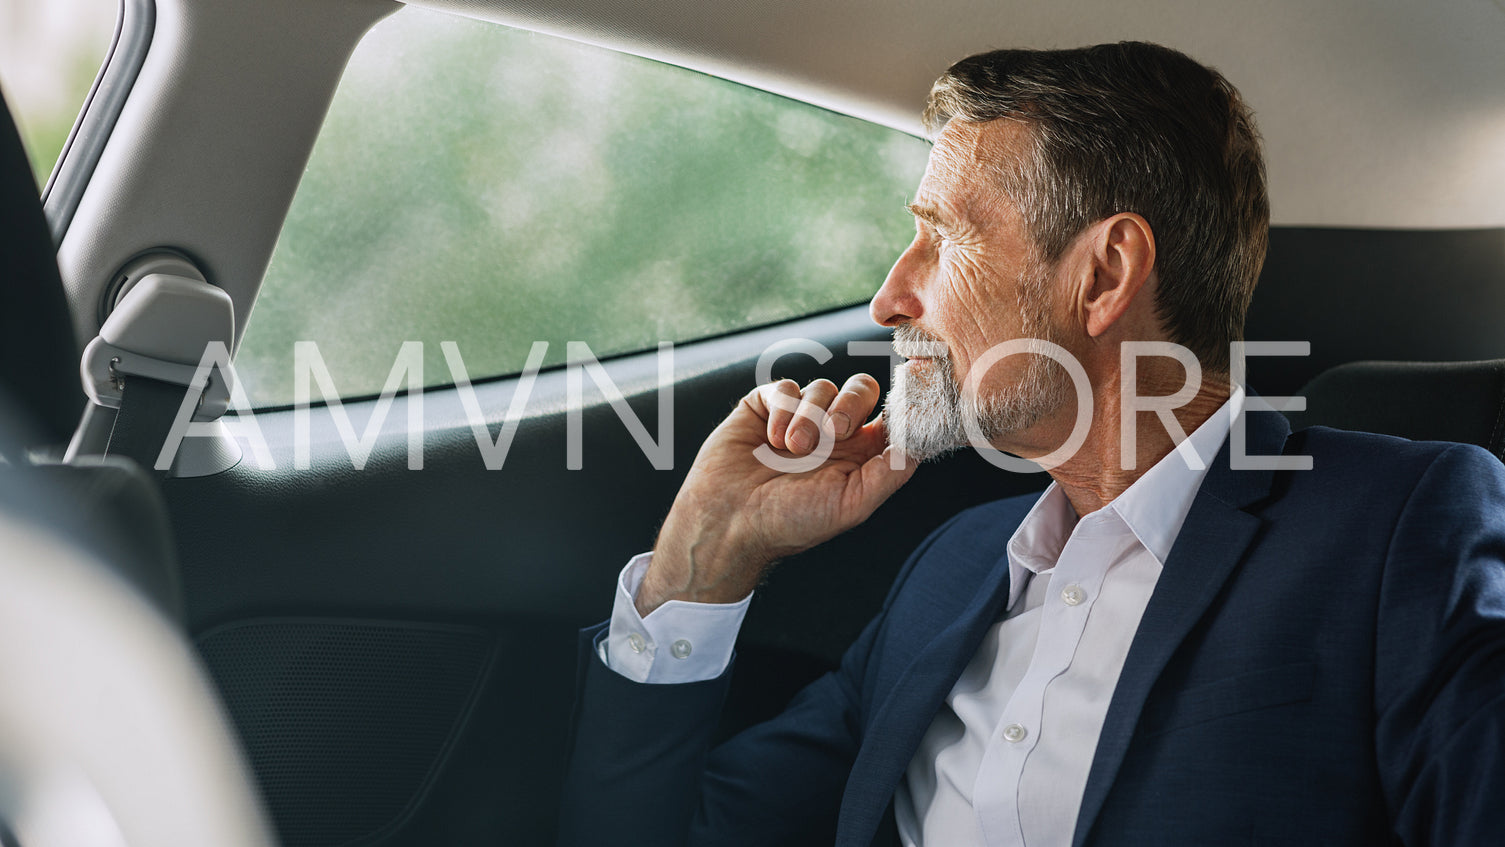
[1374,445,1505,847]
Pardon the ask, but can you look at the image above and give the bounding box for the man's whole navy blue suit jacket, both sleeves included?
[561,414,1505,847]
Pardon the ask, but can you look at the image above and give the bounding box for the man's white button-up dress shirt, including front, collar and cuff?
[600,390,1243,847]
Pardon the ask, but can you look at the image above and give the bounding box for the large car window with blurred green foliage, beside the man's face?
[236,8,929,406]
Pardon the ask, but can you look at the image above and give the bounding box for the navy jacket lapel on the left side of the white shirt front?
[835,544,1011,845]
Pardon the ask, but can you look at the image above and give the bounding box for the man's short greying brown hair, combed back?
[924,42,1270,373]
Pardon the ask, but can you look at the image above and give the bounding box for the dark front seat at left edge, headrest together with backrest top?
[0,88,184,623]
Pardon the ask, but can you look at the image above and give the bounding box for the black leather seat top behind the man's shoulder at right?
[1290,360,1505,462]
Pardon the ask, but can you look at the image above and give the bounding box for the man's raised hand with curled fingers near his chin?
[637,373,915,615]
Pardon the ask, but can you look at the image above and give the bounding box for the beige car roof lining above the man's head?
[409,0,1505,227]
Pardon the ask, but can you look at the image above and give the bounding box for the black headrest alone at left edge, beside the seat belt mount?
[0,86,84,444]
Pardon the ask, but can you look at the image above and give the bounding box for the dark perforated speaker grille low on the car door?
[199,618,494,847]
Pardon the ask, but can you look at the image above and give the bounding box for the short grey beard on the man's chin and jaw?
[883,325,1073,462]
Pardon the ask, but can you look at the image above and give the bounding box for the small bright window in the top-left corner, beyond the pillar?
[0,0,120,185]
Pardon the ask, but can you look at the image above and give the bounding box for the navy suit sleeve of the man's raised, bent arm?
[558,519,956,847]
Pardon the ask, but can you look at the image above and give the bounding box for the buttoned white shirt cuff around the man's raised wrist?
[596,554,753,683]
